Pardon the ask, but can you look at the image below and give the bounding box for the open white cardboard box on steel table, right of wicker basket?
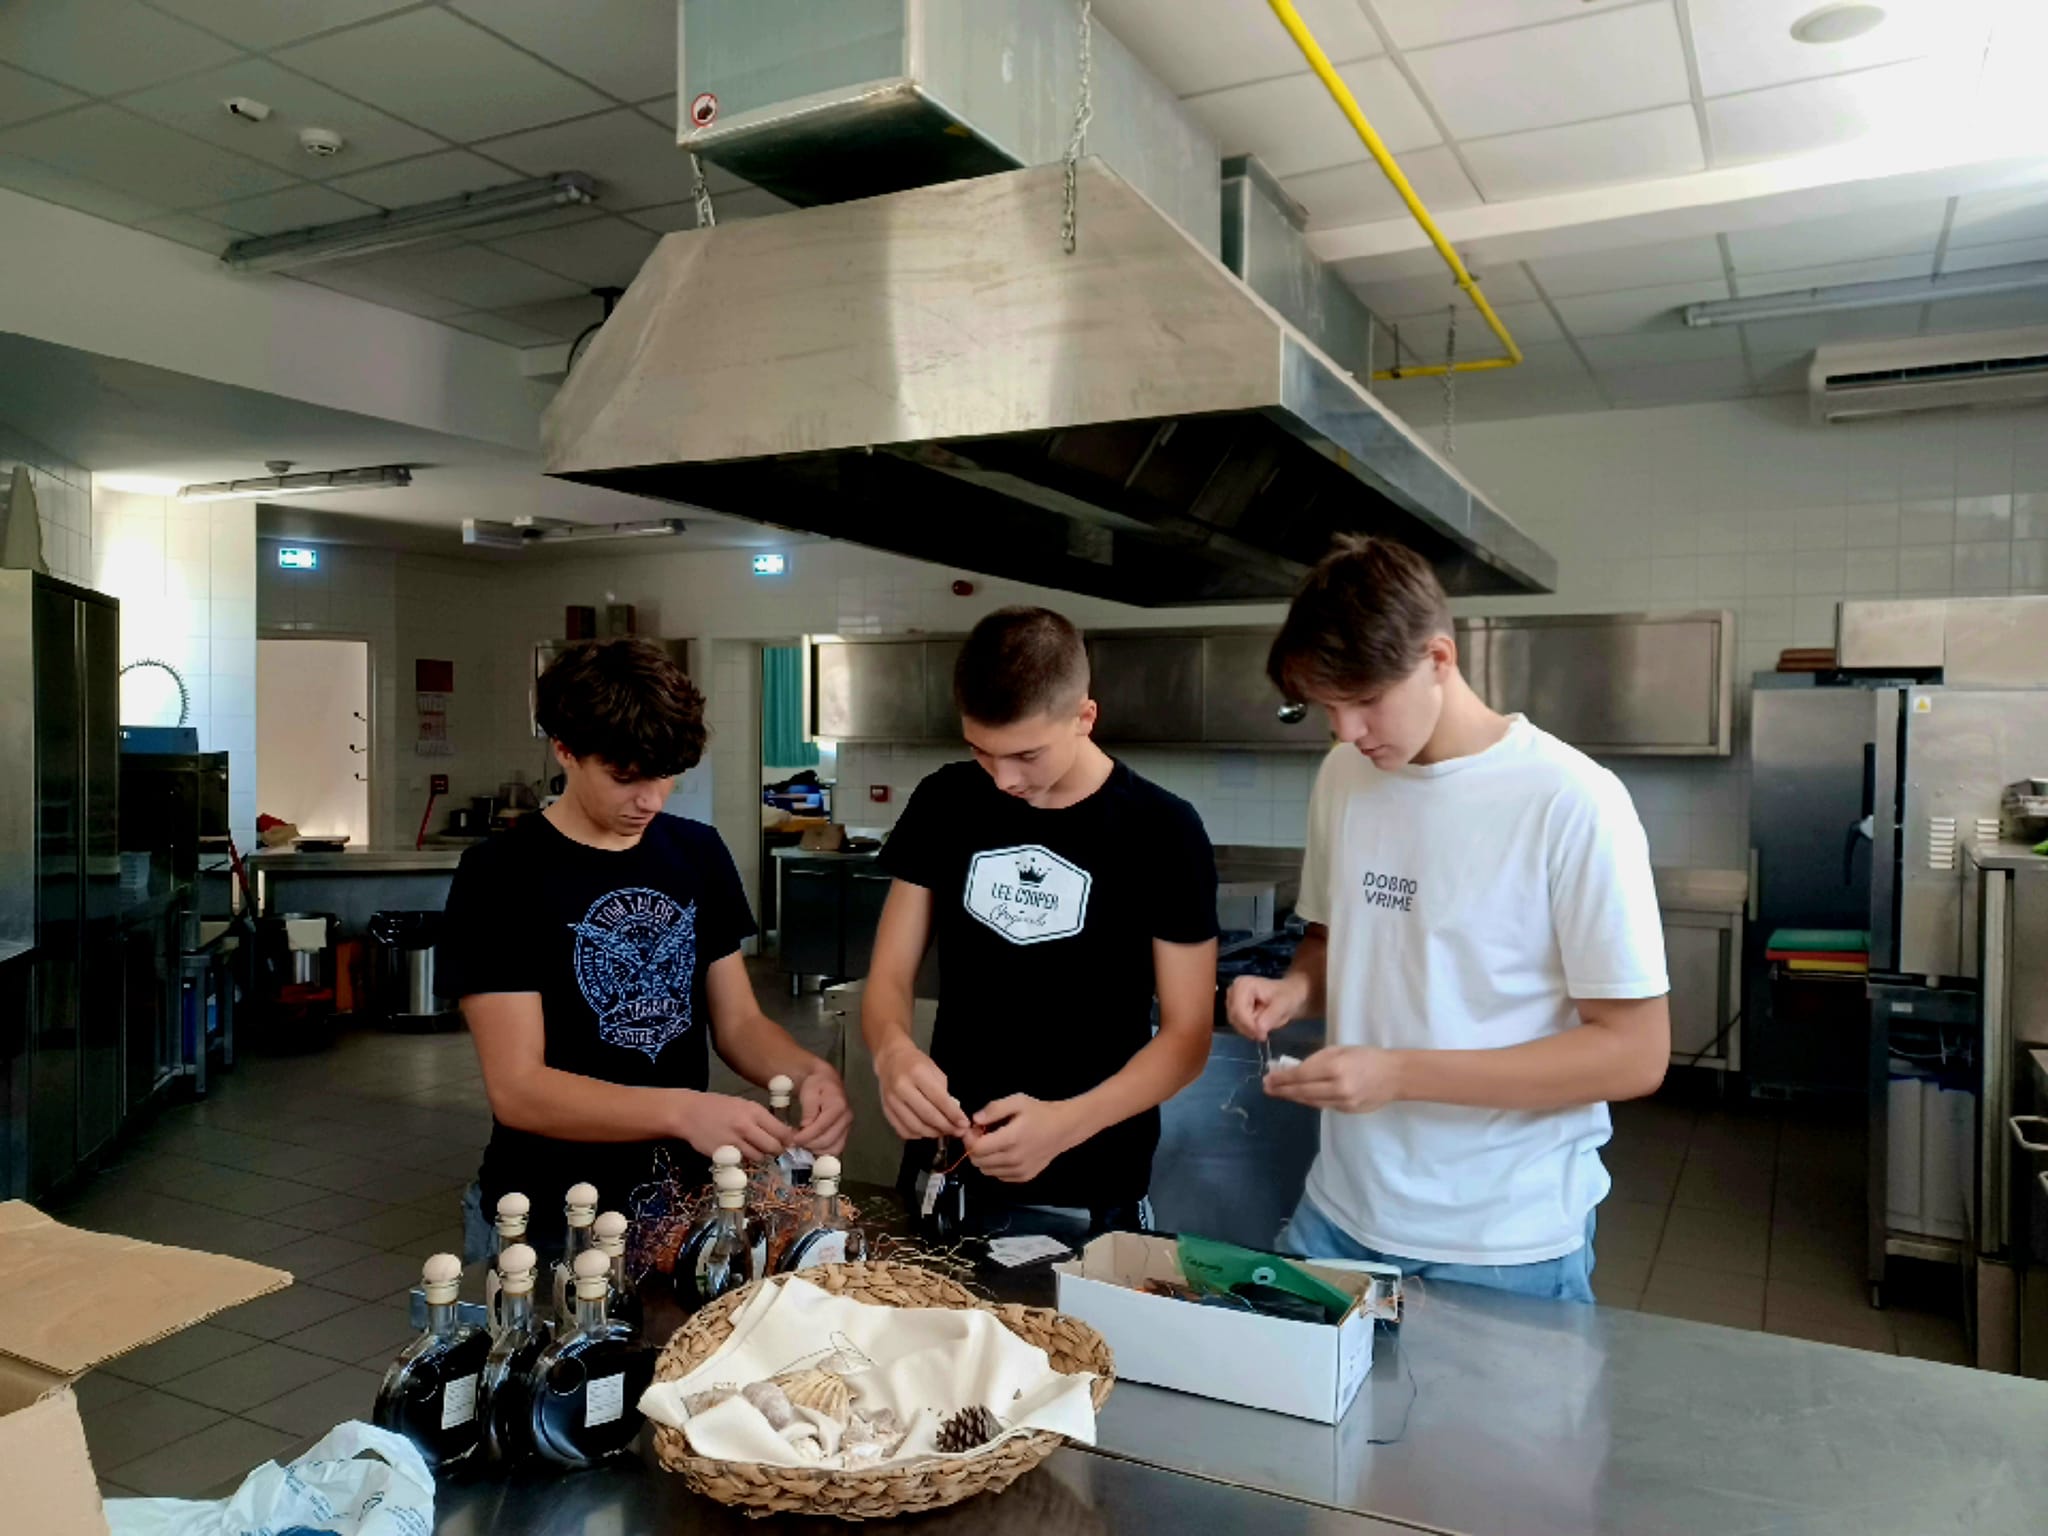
[1053,1233,1399,1423]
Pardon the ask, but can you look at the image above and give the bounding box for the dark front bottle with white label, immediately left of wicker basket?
[526,1249,655,1466]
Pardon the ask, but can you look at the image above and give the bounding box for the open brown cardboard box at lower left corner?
[0,1200,291,1536]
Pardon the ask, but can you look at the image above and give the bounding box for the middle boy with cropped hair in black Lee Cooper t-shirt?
[860,608,1217,1235]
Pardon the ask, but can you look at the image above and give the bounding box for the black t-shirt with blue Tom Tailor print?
[436,815,754,1247]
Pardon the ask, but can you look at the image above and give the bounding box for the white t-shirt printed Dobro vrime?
[1298,715,1669,1264]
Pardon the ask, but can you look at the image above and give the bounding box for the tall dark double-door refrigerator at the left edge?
[0,571,123,1196]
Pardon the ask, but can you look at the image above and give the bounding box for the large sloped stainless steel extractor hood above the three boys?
[545,160,1556,606]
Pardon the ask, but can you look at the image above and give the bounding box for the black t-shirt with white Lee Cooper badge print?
[883,762,1217,1210]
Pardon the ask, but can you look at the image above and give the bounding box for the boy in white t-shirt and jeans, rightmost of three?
[1229,539,1671,1303]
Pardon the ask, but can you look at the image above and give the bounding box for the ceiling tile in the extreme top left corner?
[0,0,236,96]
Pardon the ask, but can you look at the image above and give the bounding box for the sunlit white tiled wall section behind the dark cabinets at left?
[92,487,256,848]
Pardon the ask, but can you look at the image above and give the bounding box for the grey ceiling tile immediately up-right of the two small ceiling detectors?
[276,8,608,143]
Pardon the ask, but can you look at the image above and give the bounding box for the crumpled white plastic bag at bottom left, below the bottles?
[106,1421,434,1536]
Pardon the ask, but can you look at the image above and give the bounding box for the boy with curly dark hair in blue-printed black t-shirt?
[440,639,852,1257]
